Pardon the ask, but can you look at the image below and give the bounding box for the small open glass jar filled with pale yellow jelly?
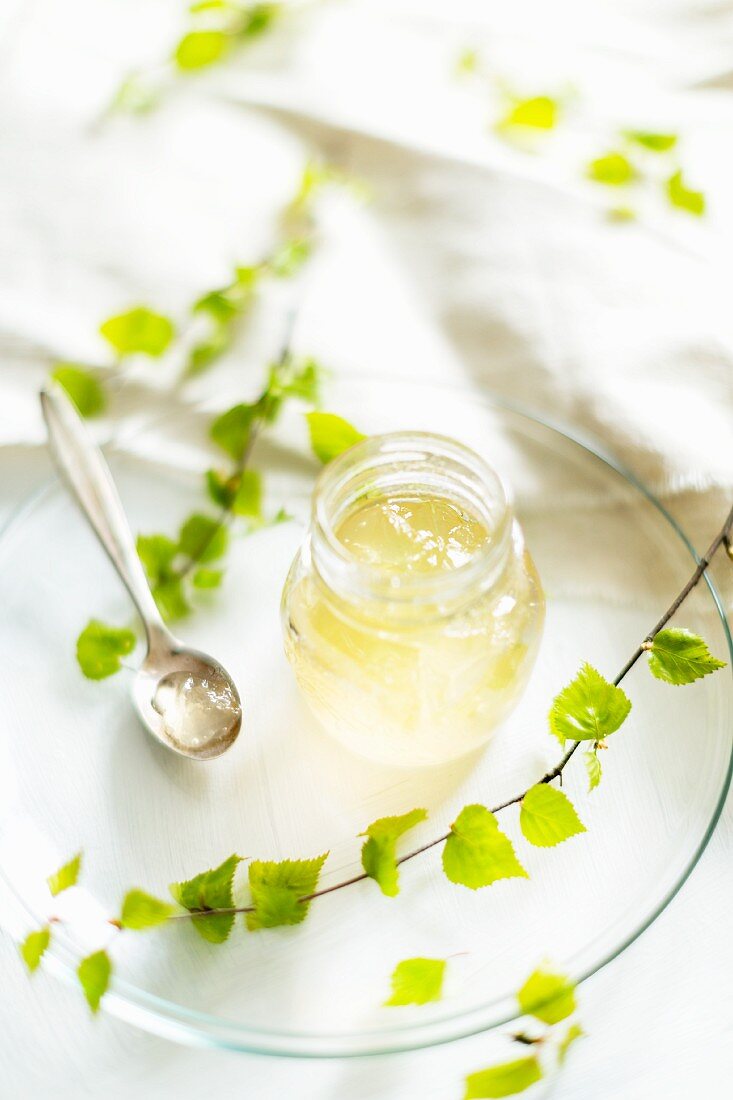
[283,432,545,767]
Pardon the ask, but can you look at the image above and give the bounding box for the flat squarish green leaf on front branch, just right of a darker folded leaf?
[247,853,328,932]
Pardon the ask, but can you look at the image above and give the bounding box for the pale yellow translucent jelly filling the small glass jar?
[284,492,544,767]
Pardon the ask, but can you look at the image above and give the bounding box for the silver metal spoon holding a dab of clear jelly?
[41,383,242,760]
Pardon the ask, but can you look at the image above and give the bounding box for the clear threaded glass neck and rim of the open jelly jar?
[310,432,512,620]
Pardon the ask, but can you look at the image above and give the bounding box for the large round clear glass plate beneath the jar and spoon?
[0,376,733,1057]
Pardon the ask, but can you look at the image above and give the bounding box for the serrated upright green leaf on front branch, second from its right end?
[549,663,631,745]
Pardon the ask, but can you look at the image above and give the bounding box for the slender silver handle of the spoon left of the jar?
[41,384,168,648]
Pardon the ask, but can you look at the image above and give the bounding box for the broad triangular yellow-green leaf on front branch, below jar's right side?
[442,805,529,890]
